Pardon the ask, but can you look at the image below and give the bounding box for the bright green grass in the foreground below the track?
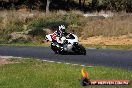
[0,59,132,88]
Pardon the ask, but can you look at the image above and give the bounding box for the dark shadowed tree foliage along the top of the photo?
[0,0,132,12]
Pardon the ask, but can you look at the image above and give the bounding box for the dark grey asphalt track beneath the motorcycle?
[0,46,132,70]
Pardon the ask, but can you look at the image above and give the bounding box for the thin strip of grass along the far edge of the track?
[0,42,132,50]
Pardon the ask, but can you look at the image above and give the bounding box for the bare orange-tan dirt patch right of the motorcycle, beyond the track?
[80,35,132,45]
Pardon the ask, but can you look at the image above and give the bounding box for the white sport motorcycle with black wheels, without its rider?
[45,33,86,55]
